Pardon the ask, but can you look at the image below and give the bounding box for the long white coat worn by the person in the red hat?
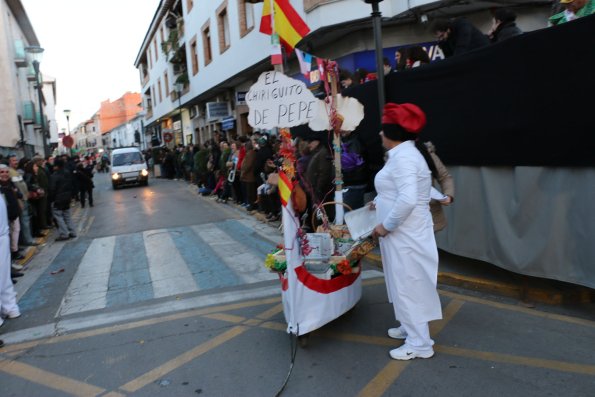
[374,141,442,324]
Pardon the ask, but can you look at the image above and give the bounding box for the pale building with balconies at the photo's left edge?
[0,0,58,157]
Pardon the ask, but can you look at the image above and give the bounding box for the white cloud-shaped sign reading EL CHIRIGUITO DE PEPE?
[246,71,318,129]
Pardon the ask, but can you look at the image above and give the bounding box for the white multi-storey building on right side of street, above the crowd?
[135,0,551,145]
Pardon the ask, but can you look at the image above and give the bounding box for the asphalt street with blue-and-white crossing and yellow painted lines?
[0,174,595,397]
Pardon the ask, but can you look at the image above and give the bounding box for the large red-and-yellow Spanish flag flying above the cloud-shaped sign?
[260,0,310,53]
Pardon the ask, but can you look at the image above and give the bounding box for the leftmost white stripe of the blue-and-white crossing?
[58,236,116,316]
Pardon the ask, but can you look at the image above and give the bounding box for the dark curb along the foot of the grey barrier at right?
[366,252,595,306]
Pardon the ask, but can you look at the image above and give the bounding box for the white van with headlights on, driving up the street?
[110,147,149,189]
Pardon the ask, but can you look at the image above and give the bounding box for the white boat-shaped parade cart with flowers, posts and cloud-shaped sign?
[246,61,374,336]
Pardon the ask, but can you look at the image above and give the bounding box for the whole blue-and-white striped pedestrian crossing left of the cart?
[19,219,279,317]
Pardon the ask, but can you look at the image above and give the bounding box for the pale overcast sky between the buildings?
[21,0,160,131]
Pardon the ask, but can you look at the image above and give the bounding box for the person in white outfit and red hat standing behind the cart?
[372,103,442,360]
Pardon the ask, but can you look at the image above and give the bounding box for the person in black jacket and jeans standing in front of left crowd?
[49,159,76,241]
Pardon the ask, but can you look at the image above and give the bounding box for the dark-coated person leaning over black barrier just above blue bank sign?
[432,18,490,58]
